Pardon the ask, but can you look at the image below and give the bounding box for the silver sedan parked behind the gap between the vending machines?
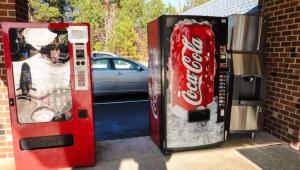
[92,52,148,96]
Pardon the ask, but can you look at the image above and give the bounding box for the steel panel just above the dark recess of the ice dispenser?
[232,53,264,75]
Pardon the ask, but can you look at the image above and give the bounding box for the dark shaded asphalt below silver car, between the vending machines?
[94,94,149,141]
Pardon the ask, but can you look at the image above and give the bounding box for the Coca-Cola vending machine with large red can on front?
[148,15,229,153]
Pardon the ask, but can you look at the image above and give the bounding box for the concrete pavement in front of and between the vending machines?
[0,132,282,170]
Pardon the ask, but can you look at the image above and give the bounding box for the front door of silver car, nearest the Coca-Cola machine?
[112,58,147,92]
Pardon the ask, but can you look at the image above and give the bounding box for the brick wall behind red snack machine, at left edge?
[0,0,28,158]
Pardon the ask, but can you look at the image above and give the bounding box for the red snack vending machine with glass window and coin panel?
[1,23,95,170]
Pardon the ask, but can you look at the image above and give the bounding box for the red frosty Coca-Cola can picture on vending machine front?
[169,19,216,112]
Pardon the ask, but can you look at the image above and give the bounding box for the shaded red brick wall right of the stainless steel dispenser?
[261,0,300,149]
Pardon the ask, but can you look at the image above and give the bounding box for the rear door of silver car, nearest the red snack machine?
[92,58,115,96]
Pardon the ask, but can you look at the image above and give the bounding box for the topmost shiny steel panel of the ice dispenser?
[227,15,263,52]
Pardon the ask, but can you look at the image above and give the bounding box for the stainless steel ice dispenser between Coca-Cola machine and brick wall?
[227,15,267,138]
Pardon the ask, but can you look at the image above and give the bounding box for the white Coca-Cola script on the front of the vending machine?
[181,35,203,106]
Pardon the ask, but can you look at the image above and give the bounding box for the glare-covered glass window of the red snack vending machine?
[9,28,72,124]
